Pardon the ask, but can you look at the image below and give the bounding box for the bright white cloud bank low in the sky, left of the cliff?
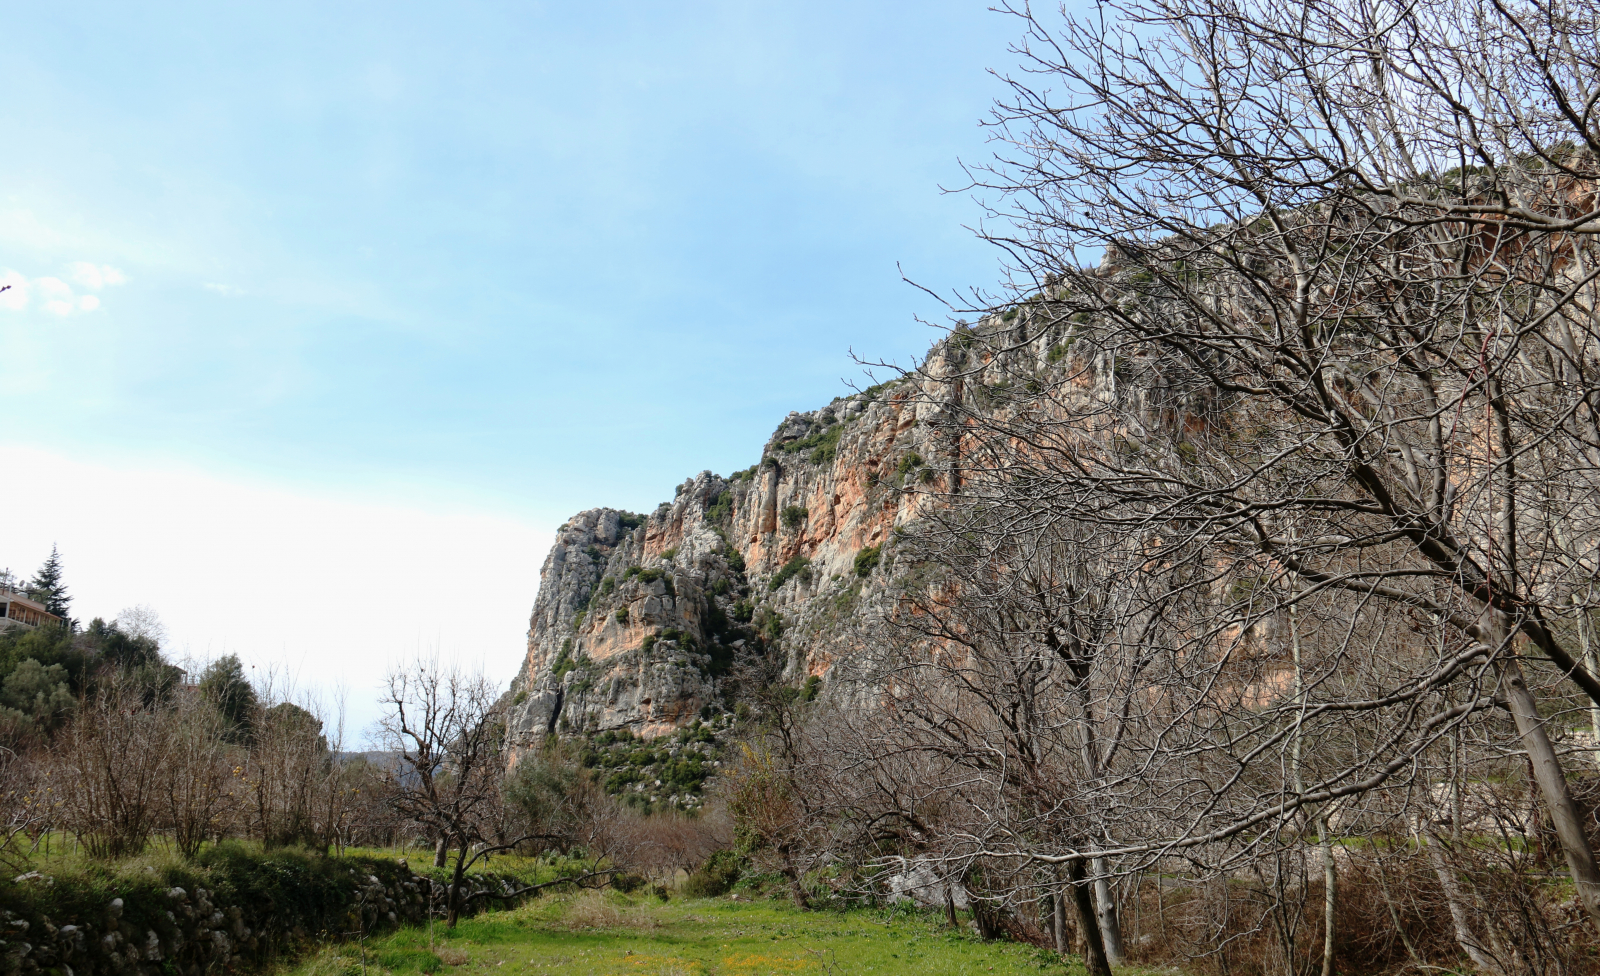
[0,446,555,739]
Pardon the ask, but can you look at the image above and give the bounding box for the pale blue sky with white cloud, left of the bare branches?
[0,0,1018,734]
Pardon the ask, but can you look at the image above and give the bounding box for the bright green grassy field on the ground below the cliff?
[283,891,1136,976]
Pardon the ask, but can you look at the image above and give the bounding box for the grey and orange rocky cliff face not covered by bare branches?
[510,317,1062,761]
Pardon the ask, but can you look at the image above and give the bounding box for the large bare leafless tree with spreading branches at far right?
[851,0,1600,934]
